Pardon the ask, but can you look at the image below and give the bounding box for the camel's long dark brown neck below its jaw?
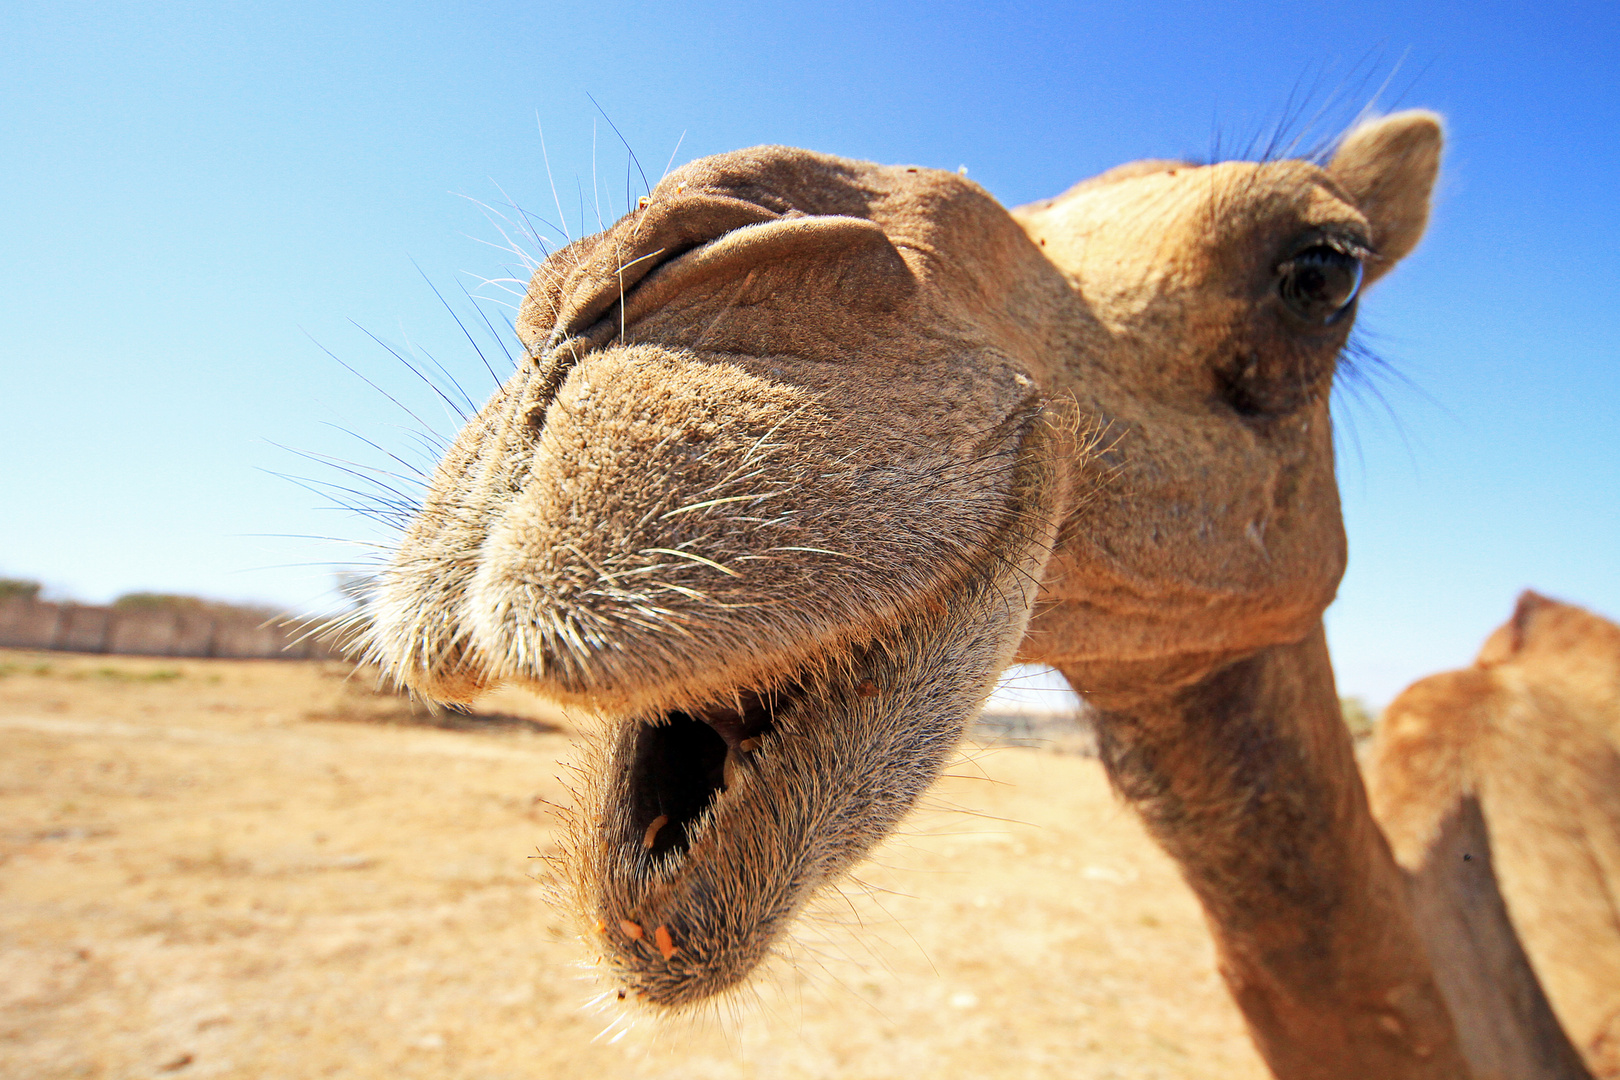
[1056,623,1468,1080]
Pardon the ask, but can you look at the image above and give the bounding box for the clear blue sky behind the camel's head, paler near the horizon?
[0,0,1620,701]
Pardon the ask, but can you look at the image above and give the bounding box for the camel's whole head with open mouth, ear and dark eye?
[373,113,1440,1007]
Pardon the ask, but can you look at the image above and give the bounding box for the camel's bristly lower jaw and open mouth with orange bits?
[573,615,997,1009]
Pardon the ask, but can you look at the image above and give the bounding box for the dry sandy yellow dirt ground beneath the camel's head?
[0,651,1265,1080]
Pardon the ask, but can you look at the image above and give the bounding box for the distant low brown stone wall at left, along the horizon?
[0,597,340,661]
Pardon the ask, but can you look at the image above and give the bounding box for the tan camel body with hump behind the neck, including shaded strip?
[1367,593,1620,1080]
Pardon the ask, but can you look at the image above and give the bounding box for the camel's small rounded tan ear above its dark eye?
[1327,108,1445,282]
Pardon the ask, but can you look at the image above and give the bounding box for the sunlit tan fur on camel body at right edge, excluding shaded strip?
[1371,593,1620,1078]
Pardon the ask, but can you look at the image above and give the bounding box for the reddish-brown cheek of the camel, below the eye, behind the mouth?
[1024,396,1346,687]
